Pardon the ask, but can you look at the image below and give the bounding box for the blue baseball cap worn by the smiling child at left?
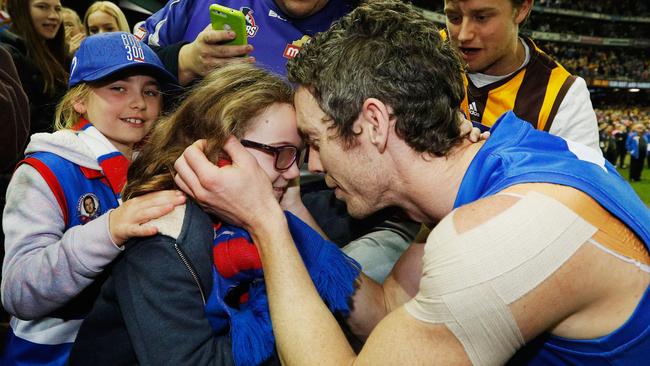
[68,32,178,88]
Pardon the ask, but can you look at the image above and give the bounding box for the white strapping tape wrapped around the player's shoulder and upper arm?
[405,192,597,365]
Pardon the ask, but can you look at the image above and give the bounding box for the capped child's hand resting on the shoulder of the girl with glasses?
[108,190,185,246]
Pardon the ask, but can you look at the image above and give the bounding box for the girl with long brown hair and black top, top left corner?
[0,0,69,134]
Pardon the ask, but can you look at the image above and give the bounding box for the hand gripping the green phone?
[178,24,255,85]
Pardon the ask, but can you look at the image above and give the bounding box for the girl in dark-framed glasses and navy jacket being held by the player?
[70,64,359,366]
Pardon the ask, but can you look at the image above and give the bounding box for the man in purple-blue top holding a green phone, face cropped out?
[135,0,358,85]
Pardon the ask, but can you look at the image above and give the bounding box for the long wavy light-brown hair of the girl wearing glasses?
[122,64,293,200]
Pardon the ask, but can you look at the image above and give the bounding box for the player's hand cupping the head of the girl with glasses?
[174,136,283,231]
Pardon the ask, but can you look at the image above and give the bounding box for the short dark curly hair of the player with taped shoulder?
[287,0,464,156]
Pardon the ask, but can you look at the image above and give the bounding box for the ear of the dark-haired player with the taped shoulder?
[361,98,394,153]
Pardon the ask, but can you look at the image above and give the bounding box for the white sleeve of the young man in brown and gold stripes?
[548,77,602,154]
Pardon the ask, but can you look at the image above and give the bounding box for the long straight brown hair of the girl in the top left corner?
[7,0,69,96]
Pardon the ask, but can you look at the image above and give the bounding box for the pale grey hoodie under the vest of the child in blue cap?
[2,130,121,344]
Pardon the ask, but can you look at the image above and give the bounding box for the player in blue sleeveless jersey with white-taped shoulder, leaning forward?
[175,0,650,365]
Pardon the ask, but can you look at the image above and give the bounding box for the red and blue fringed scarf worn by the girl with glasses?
[205,212,361,366]
